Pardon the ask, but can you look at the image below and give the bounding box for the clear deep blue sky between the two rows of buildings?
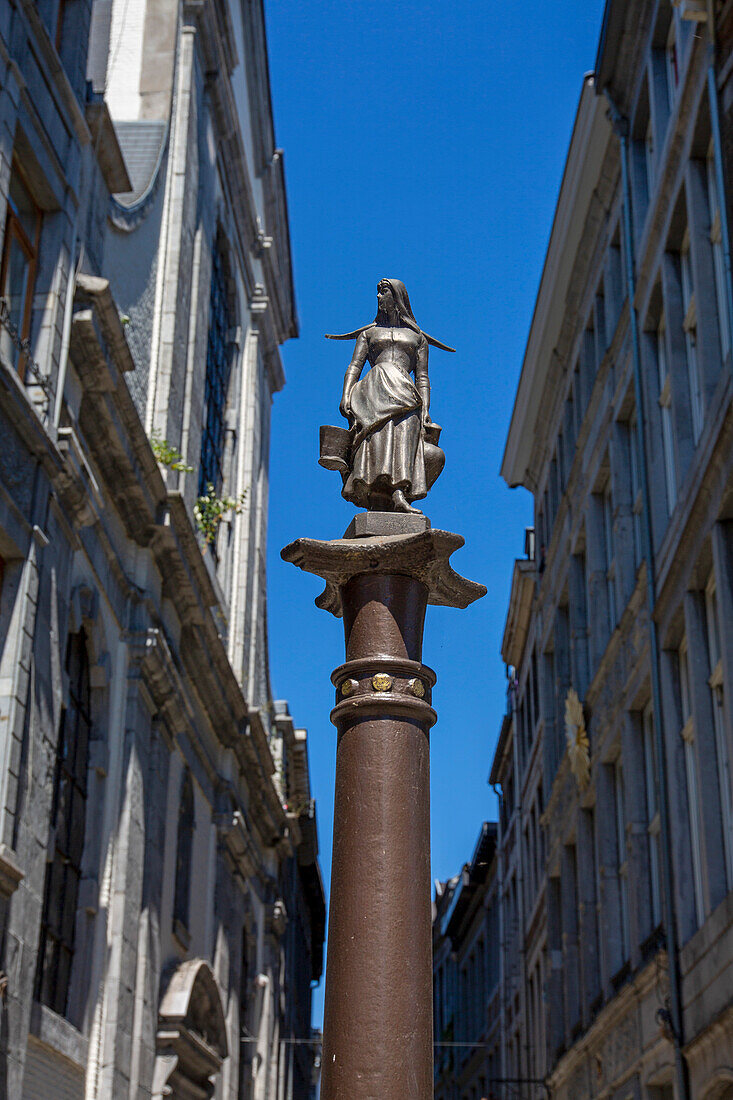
[266,0,603,1023]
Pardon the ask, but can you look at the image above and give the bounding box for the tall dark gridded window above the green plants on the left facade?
[198,234,233,494]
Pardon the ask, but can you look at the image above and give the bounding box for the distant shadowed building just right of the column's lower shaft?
[433,822,501,1100]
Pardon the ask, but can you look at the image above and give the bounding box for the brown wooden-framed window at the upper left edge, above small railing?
[0,163,41,371]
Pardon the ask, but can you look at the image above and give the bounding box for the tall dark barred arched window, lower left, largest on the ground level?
[36,629,91,1015]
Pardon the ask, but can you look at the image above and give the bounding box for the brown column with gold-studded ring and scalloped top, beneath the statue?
[282,513,486,1100]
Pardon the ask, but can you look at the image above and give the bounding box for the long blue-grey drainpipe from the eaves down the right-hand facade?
[604,89,686,1100]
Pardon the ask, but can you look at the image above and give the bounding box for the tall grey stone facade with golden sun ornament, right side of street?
[491,0,733,1100]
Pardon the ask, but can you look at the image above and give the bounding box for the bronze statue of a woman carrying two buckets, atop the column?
[319,278,455,513]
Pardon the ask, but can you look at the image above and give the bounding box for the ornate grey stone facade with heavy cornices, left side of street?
[0,0,325,1100]
